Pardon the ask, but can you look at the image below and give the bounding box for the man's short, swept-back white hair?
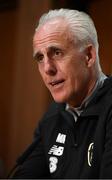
[36,9,101,69]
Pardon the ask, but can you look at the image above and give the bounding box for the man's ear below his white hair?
[85,44,96,67]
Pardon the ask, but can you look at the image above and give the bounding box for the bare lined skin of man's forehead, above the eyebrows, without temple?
[33,19,69,48]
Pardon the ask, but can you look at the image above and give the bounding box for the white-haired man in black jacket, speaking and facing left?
[10,9,112,179]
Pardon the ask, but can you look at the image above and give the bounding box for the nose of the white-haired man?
[44,58,57,76]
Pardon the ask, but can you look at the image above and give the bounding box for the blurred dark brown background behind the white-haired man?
[0,0,112,178]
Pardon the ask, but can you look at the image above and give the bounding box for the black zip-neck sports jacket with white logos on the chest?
[13,77,112,179]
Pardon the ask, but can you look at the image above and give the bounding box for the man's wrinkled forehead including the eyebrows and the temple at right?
[33,19,74,55]
